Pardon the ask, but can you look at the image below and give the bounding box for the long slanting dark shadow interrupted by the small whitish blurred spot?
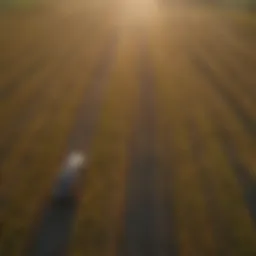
[27,37,116,256]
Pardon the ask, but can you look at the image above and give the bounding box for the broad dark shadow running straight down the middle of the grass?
[119,41,177,256]
